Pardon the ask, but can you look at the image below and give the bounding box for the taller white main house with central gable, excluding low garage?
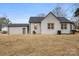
[29,12,75,34]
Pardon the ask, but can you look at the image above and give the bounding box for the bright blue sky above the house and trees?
[0,3,75,23]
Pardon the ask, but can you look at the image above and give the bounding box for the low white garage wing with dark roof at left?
[8,24,29,35]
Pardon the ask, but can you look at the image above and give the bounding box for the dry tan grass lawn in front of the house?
[0,33,79,56]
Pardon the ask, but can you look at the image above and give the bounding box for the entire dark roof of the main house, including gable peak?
[29,12,72,23]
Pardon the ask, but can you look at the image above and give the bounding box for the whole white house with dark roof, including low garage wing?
[1,12,75,34]
